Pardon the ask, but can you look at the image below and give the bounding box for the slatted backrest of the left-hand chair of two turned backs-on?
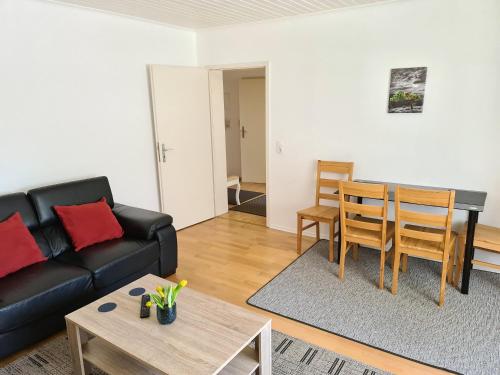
[339,181,388,247]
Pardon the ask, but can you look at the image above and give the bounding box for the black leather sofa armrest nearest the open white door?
[113,203,172,240]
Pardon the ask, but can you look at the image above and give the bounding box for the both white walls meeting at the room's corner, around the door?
[0,0,500,268]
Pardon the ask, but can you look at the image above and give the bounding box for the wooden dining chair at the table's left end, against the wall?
[297,160,354,262]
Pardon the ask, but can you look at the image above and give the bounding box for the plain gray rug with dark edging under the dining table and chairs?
[248,240,500,375]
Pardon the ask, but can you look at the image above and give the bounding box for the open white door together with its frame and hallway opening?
[149,63,270,230]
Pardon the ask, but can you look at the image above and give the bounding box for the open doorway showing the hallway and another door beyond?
[223,67,268,225]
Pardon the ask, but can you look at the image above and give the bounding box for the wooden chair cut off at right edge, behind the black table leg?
[453,223,500,286]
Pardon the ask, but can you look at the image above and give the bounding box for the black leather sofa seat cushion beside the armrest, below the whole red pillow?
[55,238,160,289]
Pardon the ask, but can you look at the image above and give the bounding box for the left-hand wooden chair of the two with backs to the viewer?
[339,181,395,289]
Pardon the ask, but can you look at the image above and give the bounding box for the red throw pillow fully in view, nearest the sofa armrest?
[54,198,123,251]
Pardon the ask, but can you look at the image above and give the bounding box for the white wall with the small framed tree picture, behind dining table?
[198,0,500,231]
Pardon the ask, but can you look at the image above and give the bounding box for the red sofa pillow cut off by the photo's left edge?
[0,212,47,277]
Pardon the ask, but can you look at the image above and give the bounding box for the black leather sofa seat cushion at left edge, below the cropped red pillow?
[0,260,93,332]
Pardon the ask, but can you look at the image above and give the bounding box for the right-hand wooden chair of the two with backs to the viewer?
[392,186,457,306]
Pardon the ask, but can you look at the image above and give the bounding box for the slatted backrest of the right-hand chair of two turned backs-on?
[394,186,455,256]
